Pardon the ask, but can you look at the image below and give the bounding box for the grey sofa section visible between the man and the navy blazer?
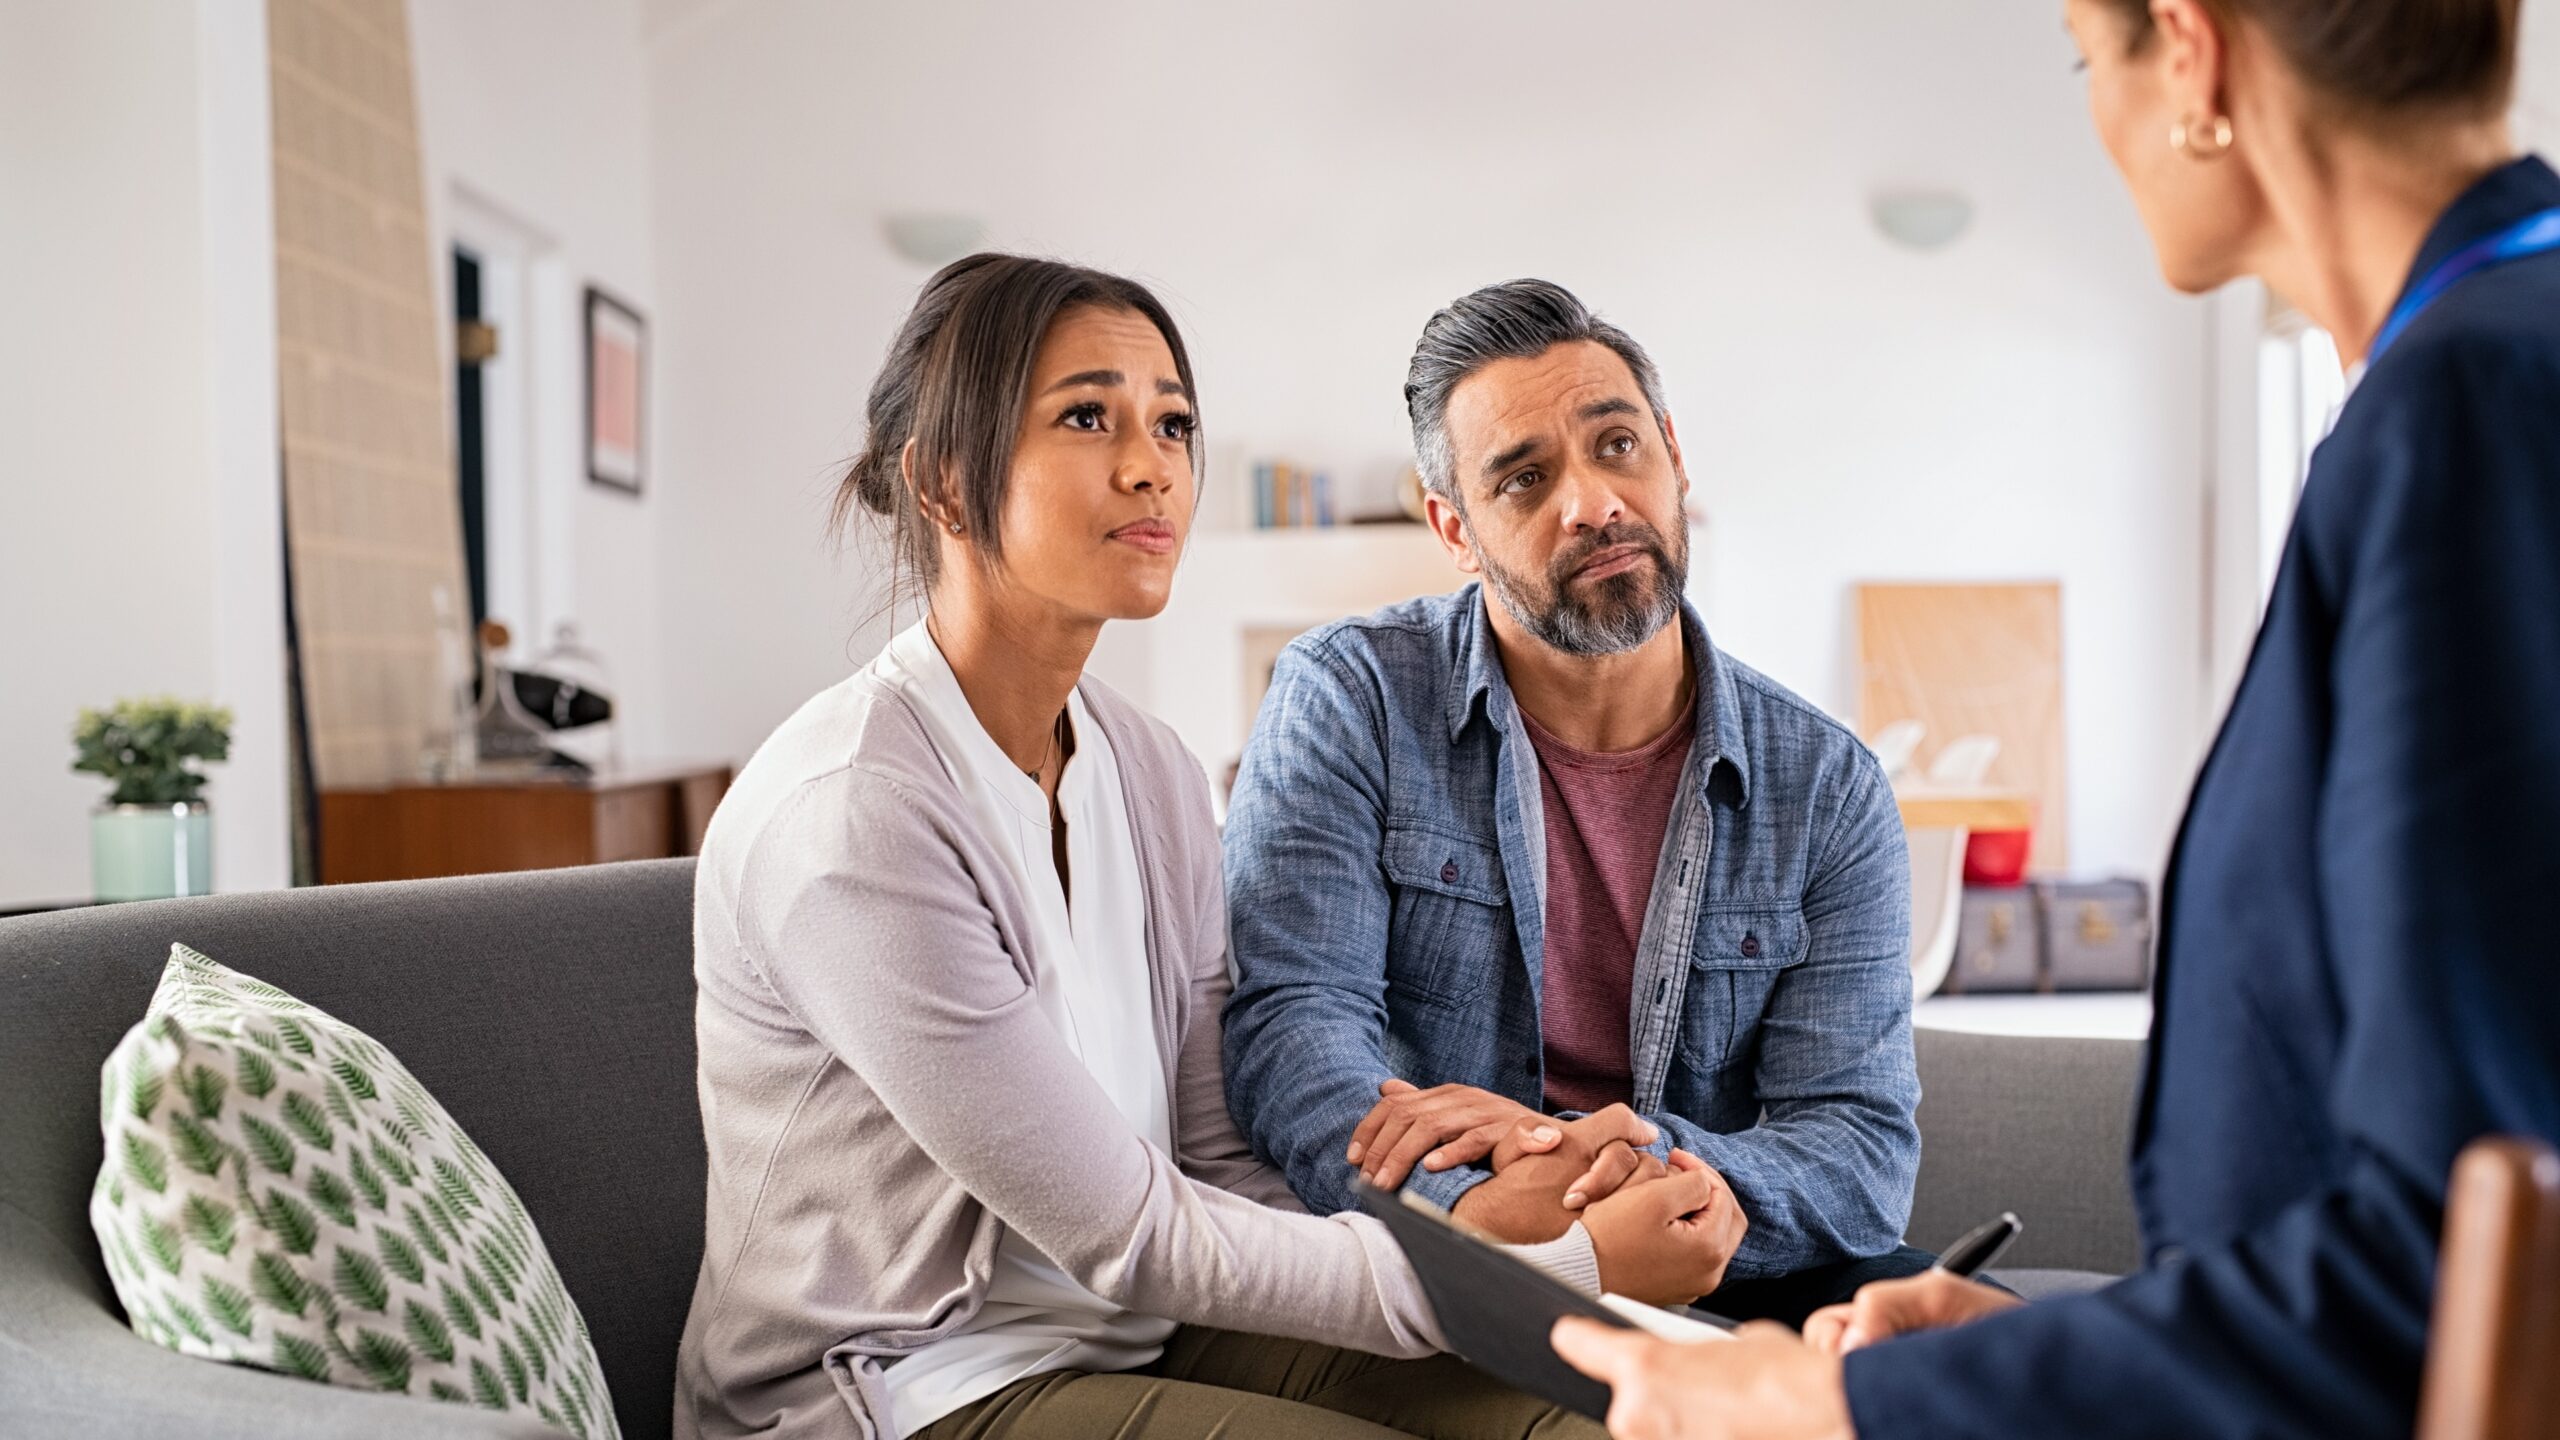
[1910,1027,2143,1276]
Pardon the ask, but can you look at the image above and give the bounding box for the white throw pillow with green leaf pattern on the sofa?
[90,945,620,1440]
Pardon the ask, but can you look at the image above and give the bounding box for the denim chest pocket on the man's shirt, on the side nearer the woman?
[1377,828,1510,1007]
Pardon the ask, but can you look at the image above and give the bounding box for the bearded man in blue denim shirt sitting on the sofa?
[1226,279,1930,1322]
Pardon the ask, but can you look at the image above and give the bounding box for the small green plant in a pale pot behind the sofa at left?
[72,700,230,902]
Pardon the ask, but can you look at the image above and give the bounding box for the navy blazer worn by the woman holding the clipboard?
[1846,159,2560,1440]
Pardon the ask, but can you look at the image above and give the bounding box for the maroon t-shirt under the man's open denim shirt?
[1521,712,1695,1109]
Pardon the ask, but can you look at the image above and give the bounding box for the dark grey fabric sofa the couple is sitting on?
[0,861,2138,1440]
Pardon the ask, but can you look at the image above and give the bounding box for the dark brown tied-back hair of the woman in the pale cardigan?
[829,254,1201,592]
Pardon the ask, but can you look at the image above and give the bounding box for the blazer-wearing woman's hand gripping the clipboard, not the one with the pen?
[1551,1320,1856,1440]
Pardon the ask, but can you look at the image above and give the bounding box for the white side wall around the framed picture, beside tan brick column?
[410,0,671,758]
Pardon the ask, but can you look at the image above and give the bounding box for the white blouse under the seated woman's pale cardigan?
[873,623,1172,1440]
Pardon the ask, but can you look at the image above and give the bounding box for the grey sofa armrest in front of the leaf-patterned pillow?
[0,1204,561,1440]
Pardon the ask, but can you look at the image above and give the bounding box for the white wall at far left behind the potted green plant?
[0,0,289,904]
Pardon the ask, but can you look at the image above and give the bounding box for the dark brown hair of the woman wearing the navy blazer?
[2109,0,2522,115]
